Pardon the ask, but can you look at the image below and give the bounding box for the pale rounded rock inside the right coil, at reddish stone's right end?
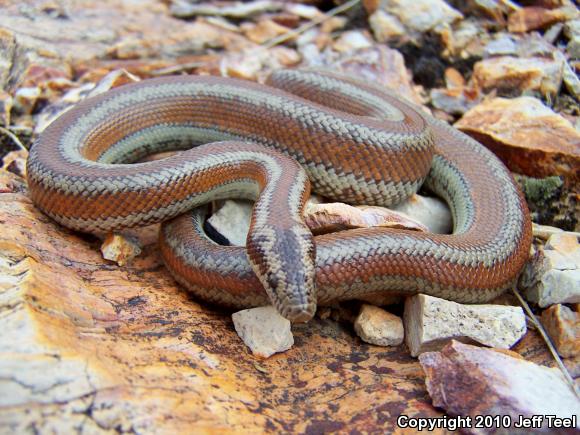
[391,194,453,234]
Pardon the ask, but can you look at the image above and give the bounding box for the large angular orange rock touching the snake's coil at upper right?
[455,97,580,186]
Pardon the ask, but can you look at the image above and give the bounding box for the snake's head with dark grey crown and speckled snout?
[246,223,316,322]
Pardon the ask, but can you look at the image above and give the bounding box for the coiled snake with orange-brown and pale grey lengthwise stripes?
[27,69,532,322]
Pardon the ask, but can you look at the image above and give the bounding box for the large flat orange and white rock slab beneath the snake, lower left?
[0,170,454,433]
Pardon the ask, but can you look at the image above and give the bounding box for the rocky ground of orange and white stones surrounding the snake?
[0,0,580,433]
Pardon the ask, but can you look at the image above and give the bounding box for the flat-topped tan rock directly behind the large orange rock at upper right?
[473,56,563,96]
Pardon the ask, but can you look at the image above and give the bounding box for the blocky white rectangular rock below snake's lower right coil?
[404,294,526,356]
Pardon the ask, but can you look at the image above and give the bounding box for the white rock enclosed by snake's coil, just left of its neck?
[208,199,253,246]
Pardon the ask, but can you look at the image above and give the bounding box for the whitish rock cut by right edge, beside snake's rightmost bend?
[520,232,580,307]
